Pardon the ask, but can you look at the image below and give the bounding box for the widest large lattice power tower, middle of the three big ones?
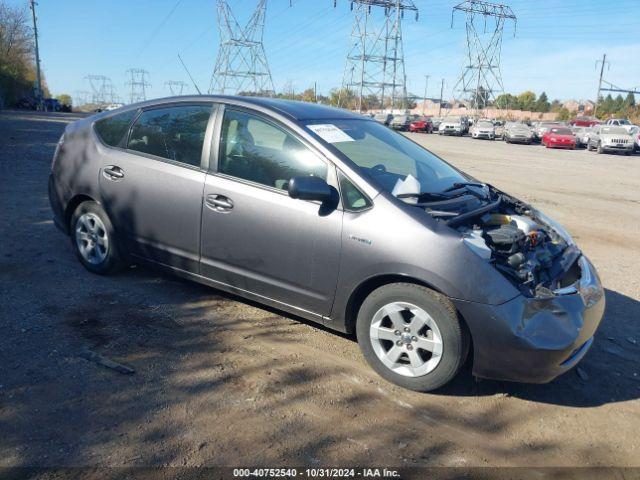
[334,0,418,112]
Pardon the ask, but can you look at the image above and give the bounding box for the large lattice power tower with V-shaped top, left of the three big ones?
[209,0,275,96]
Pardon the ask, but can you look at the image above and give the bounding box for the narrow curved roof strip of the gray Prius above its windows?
[118,95,366,121]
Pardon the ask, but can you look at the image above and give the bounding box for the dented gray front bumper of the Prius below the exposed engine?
[454,256,605,383]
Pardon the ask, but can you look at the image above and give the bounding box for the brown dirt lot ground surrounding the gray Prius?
[0,112,640,467]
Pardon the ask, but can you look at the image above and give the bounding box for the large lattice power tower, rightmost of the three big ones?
[451,0,517,115]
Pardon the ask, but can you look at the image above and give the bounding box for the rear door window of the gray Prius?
[127,105,213,167]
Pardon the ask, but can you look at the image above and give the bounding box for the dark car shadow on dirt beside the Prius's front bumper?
[436,289,640,408]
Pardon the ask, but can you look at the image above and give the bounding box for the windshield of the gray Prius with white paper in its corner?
[306,119,469,193]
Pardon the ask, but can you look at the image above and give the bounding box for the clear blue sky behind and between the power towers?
[5,0,640,100]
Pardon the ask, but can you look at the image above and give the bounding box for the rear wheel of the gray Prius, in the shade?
[69,201,123,275]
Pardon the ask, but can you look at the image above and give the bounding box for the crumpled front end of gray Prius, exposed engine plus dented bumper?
[418,186,605,383]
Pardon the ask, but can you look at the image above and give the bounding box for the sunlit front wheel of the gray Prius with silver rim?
[356,283,469,392]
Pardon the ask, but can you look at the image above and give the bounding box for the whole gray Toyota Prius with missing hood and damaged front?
[49,96,605,391]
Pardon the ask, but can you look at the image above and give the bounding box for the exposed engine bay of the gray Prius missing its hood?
[416,186,580,298]
